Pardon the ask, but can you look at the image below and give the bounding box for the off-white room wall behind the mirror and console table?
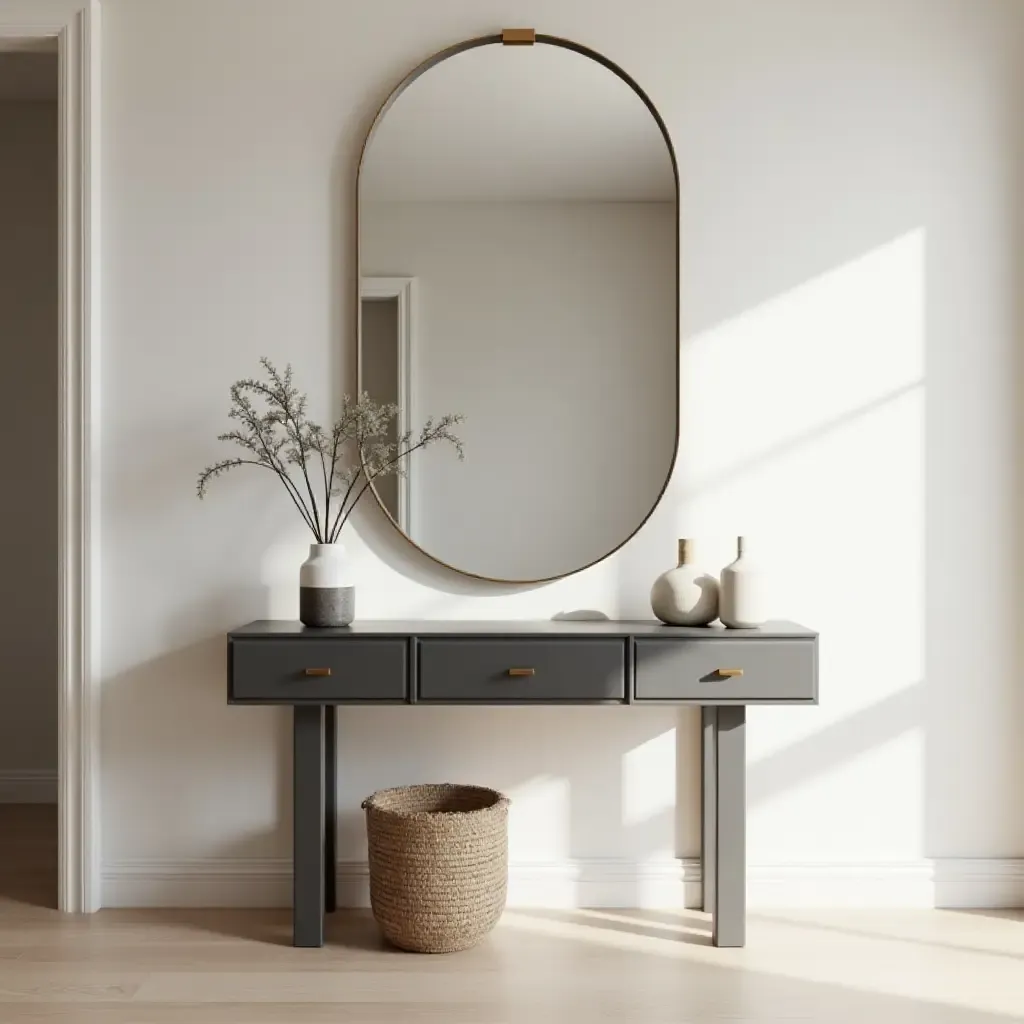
[100,0,1024,901]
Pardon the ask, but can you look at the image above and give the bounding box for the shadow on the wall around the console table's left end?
[101,588,292,866]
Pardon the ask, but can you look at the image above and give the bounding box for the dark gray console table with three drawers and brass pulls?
[227,622,818,946]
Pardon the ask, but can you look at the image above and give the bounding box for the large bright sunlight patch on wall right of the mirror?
[678,229,926,854]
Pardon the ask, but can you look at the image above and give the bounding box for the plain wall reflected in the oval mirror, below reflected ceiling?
[359,202,677,580]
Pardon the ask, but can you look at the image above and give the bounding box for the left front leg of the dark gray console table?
[292,705,324,946]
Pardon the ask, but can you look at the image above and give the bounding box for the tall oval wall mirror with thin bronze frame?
[357,30,679,583]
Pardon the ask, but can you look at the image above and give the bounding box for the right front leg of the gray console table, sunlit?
[712,705,746,946]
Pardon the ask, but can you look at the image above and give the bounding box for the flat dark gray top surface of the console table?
[228,618,817,640]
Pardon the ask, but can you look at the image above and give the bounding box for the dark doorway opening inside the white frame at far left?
[0,40,60,908]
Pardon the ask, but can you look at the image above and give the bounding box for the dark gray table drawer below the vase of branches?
[228,637,409,703]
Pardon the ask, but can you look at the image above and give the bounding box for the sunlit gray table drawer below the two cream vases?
[636,638,818,703]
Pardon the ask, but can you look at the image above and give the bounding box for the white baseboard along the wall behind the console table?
[102,858,1024,909]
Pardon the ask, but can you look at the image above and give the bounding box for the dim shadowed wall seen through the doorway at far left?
[0,99,57,802]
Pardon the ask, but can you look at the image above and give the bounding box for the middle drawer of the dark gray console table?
[419,639,626,703]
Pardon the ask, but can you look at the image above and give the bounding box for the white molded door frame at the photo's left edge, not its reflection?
[0,0,100,912]
